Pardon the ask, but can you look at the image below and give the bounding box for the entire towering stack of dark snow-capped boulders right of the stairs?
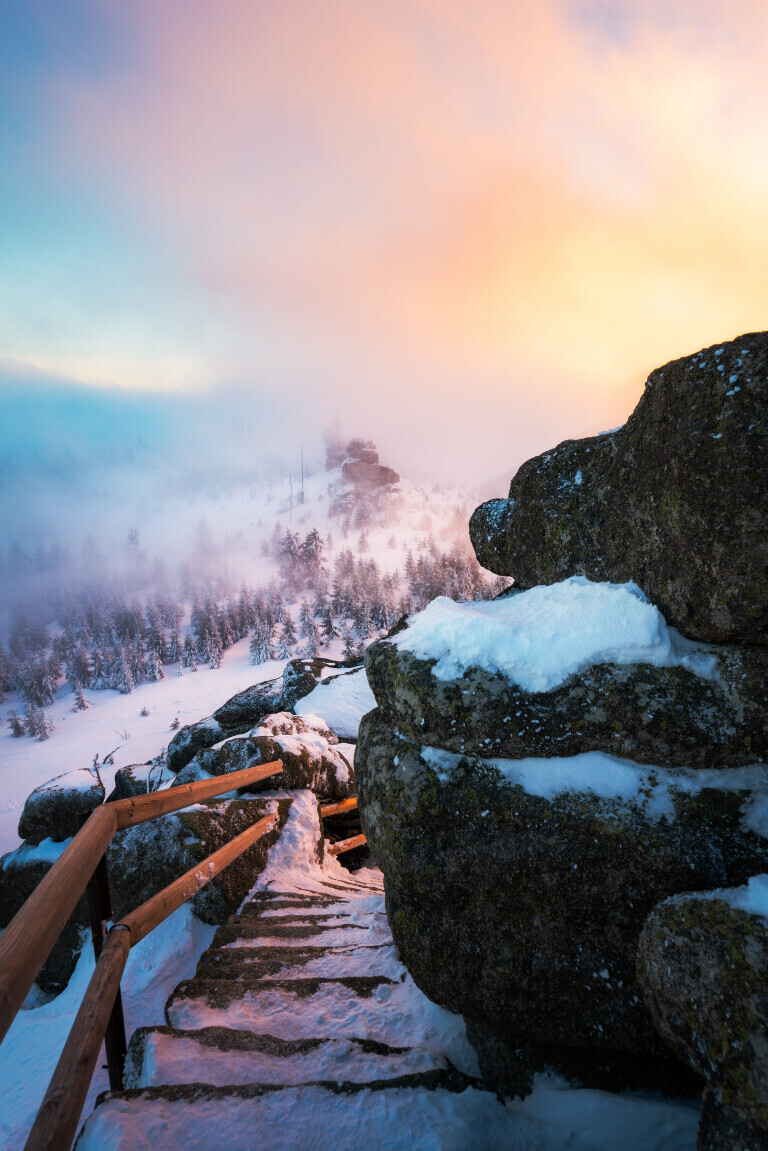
[355,333,768,1151]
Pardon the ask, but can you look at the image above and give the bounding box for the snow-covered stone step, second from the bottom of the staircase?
[124,1027,448,1088]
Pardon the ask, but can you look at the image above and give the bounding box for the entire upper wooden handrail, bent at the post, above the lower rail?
[0,760,283,1043]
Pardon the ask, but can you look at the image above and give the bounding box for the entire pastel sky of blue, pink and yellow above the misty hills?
[0,0,768,506]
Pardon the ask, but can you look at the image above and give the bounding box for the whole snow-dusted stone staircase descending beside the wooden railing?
[76,801,511,1151]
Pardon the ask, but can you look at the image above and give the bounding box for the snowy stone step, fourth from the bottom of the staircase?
[195,943,403,981]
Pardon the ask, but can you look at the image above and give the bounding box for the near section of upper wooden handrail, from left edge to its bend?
[0,803,117,1041]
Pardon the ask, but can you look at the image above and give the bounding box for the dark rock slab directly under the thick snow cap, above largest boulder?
[365,635,768,768]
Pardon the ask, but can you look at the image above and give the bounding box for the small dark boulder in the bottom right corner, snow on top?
[638,894,768,1151]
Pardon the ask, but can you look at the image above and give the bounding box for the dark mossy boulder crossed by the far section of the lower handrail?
[107,798,291,923]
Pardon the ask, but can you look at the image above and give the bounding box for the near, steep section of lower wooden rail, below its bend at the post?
[24,928,131,1151]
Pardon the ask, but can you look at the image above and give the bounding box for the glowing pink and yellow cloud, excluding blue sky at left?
[35,0,768,476]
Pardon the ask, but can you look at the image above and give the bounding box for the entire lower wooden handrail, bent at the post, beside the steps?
[24,787,282,1151]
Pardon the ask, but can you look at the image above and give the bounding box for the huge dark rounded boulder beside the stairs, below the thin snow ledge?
[356,710,768,1091]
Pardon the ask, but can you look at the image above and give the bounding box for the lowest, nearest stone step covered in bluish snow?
[76,1069,520,1151]
